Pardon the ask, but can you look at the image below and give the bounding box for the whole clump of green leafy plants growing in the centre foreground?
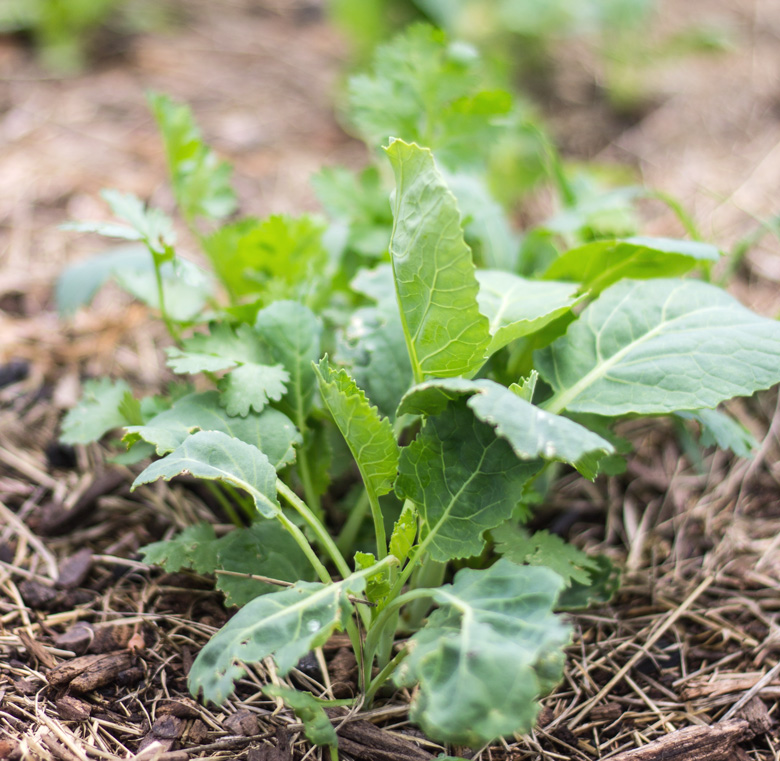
[59,37,780,747]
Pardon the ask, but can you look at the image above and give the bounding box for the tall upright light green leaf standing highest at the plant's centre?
[386,140,490,379]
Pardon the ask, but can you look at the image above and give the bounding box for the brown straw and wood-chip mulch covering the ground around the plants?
[0,0,780,761]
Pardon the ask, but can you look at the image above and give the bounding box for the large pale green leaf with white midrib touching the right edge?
[535,280,780,416]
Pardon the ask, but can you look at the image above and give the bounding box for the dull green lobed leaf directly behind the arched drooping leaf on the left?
[125,391,301,470]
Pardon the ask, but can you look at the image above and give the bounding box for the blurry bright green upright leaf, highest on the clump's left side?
[147,93,237,219]
